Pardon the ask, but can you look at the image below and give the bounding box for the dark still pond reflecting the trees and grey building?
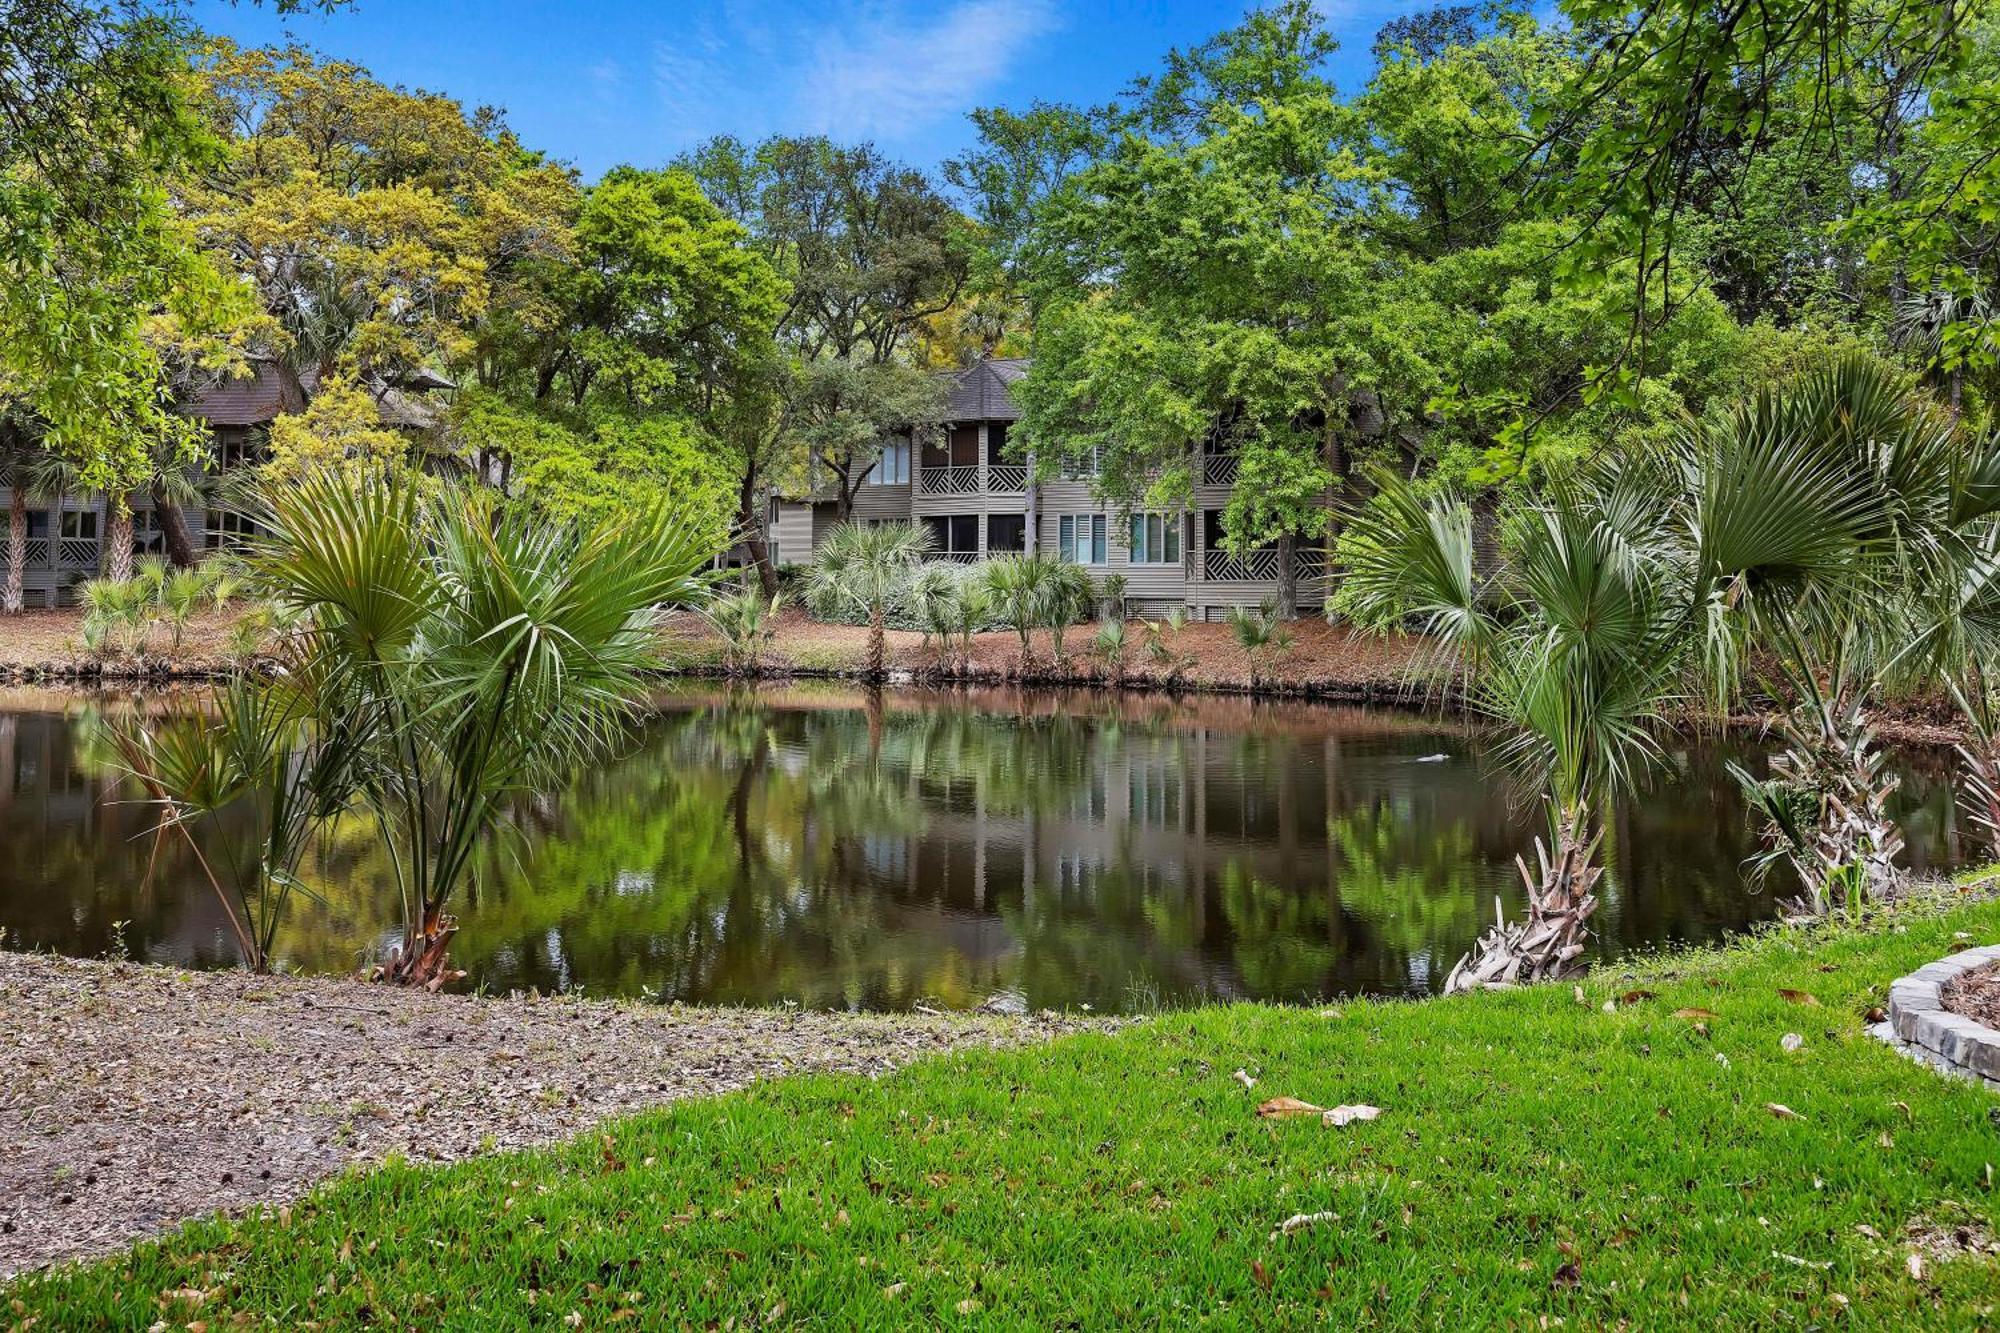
[0,687,1972,1011]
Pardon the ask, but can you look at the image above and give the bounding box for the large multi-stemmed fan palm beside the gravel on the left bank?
[128,470,714,987]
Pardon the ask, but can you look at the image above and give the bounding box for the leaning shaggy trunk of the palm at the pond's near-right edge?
[1444,809,1604,995]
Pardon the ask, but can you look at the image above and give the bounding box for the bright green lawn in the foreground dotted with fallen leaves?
[15,903,2000,1329]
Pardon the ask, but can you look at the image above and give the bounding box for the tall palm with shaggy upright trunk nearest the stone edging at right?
[1684,356,2000,911]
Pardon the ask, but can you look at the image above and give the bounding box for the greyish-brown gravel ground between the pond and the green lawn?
[0,953,1096,1275]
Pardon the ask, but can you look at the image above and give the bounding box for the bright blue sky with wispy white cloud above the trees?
[190,0,1438,178]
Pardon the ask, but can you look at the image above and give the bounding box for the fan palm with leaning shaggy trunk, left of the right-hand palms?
[1346,470,1686,991]
